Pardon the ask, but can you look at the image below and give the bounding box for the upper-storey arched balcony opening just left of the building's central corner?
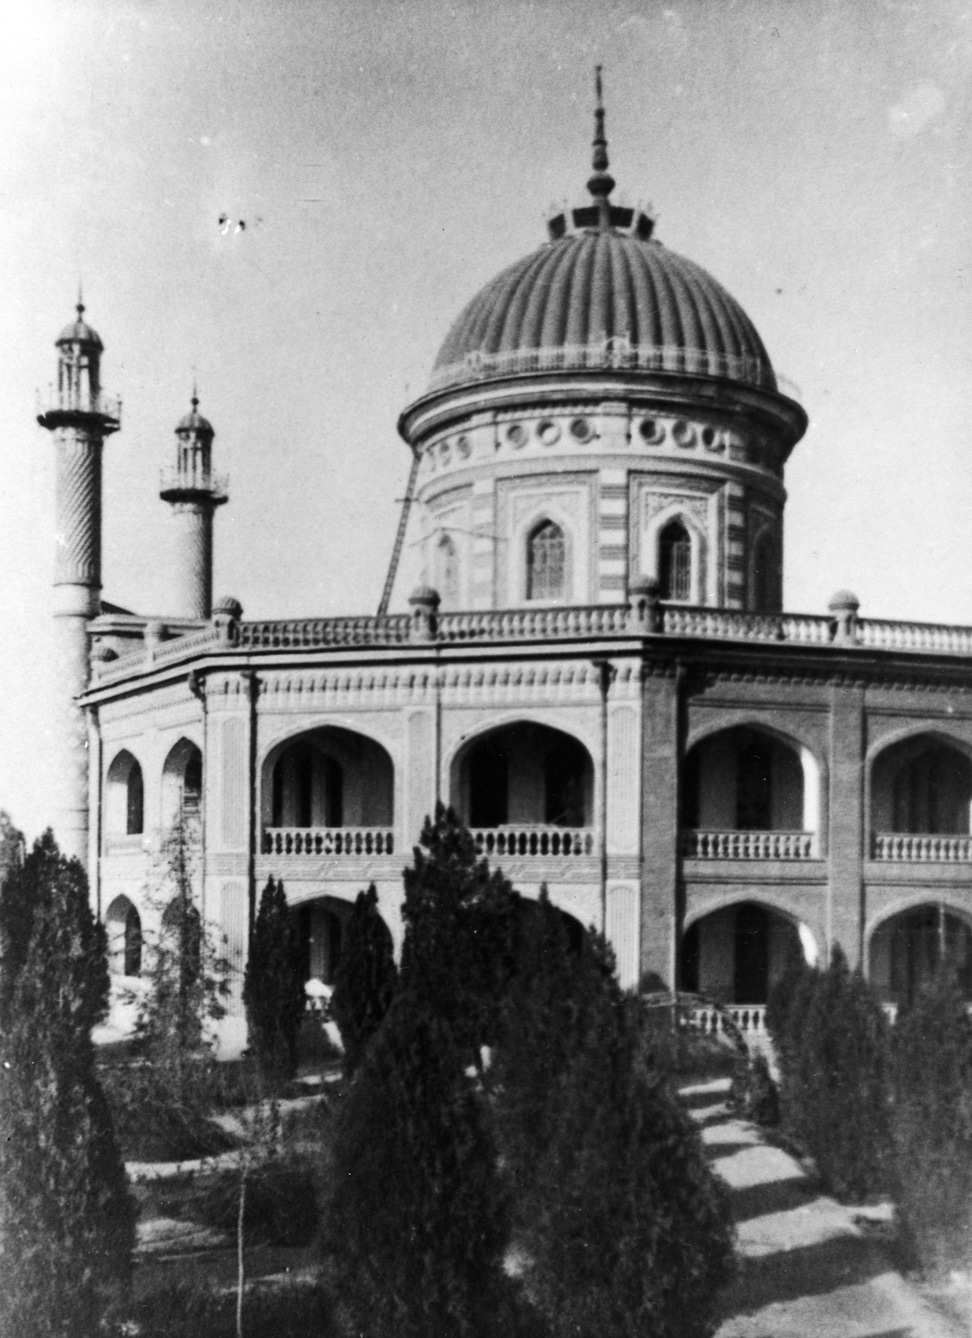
[453,721,594,855]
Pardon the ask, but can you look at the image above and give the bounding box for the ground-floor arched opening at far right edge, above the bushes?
[868,902,972,1006]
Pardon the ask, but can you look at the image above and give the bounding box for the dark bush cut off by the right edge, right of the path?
[893,971,972,1276]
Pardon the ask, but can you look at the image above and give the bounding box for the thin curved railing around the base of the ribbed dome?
[428,337,777,391]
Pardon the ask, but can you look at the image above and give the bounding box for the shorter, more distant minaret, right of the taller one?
[159,387,229,618]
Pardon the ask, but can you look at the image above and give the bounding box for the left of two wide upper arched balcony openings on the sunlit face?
[262,725,394,855]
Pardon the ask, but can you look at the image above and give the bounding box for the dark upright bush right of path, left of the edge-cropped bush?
[781,946,892,1202]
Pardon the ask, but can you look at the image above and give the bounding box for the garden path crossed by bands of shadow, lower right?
[681,1078,969,1338]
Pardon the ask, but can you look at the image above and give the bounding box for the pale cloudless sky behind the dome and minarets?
[0,0,972,836]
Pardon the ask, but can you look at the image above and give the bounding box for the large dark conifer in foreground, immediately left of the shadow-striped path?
[506,935,732,1338]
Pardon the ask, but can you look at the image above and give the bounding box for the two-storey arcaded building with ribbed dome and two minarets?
[40,91,972,1043]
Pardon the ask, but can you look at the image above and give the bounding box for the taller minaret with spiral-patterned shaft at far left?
[37,294,120,864]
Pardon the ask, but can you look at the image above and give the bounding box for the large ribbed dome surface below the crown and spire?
[431,227,777,391]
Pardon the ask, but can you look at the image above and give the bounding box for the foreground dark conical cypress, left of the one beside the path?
[327,990,511,1338]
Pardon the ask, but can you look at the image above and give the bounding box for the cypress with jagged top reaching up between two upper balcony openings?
[402,804,518,1056]
